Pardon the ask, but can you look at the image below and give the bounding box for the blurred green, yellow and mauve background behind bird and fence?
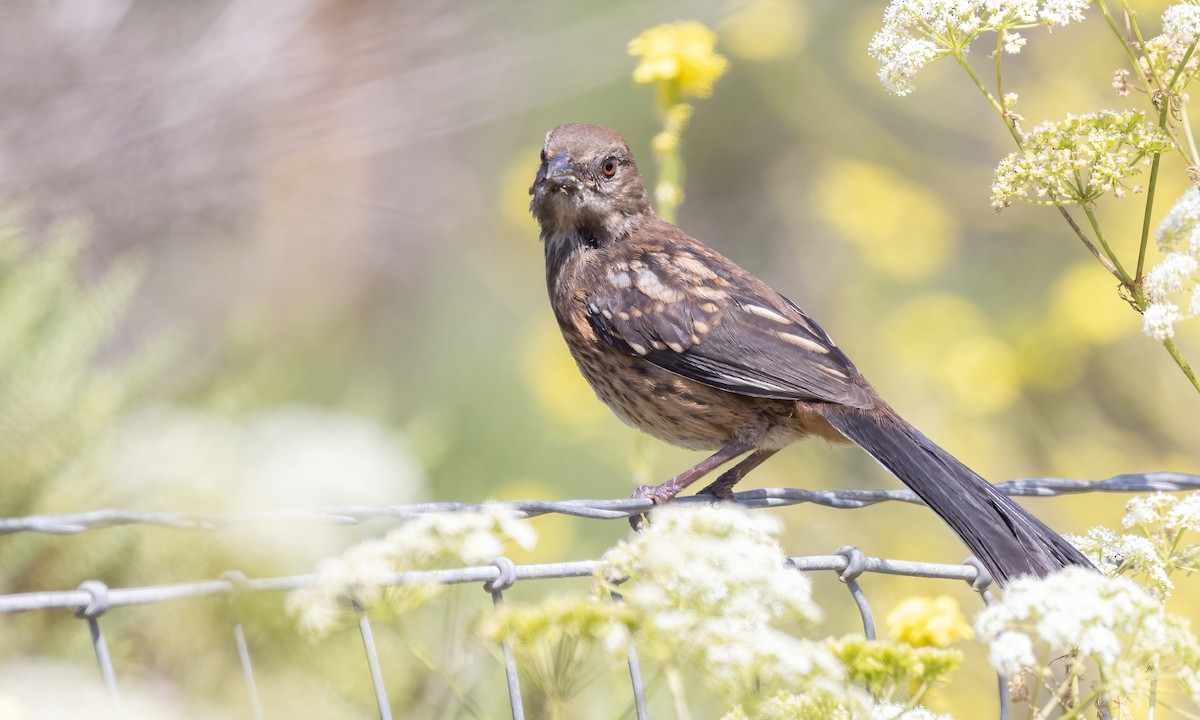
[0,0,1200,718]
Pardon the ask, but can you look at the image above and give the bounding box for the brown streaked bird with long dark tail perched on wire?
[529,124,1092,587]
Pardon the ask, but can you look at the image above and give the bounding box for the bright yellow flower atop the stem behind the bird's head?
[629,20,730,97]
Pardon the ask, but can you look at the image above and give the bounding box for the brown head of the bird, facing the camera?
[529,125,650,238]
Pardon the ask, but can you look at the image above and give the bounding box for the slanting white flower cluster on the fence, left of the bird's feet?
[287,505,538,635]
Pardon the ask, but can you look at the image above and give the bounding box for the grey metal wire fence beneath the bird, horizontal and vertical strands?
[0,473,1200,720]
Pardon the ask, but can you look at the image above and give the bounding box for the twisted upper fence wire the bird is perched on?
[0,473,1200,535]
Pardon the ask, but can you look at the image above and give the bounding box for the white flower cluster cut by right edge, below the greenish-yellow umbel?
[1141,188,1200,342]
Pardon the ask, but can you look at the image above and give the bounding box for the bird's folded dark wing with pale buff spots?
[587,250,874,408]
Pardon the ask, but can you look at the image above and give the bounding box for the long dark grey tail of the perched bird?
[822,404,1092,586]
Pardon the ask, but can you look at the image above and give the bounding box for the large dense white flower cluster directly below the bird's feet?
[596,504,845,695]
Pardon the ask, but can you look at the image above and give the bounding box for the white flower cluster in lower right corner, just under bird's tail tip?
[976,568,1200,697]
